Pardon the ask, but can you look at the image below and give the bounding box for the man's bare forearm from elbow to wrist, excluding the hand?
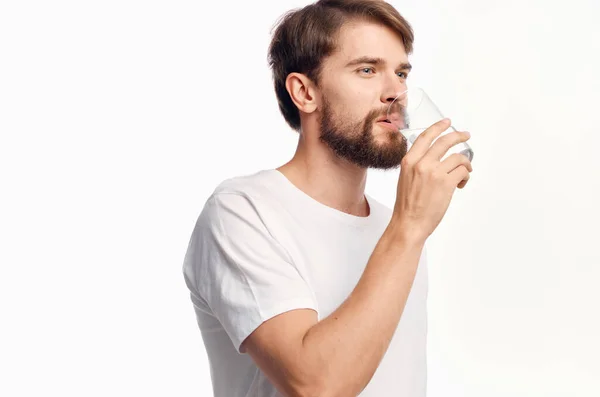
[302,224,425,396]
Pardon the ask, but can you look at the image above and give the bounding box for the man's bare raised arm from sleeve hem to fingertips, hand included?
[246,119,473,397]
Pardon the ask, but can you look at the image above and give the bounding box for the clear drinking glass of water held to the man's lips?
[387,87,473,161]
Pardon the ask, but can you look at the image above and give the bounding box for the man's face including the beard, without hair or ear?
[319,22,410,169]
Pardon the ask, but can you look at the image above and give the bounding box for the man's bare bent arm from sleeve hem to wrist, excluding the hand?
[241,223,425,397]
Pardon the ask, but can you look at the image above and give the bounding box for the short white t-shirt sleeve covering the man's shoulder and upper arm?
[184,193,318,353]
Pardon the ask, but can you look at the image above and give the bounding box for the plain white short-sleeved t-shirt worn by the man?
[183,169,427,397]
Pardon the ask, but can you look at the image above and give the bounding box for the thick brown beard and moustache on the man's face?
[319,100,407,170]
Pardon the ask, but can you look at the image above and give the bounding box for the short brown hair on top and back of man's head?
[268,0,414,131]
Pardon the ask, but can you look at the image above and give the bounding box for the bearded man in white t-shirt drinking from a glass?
[184,0,472,397]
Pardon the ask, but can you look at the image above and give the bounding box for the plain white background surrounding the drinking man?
[0,0,600,397]
